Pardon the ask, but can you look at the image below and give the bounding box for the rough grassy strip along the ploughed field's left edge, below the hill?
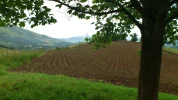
[0,50,44,75]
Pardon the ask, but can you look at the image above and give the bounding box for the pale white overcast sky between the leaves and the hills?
[25,0,140,38]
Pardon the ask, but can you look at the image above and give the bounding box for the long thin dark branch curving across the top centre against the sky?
[49,0,122,15]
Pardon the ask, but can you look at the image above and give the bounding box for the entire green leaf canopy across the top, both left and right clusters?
[0,0,178,43]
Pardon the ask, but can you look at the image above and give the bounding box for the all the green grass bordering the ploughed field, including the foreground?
[0,49,178,100]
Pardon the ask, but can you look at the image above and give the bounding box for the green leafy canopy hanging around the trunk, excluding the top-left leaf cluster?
[49,0,178,44]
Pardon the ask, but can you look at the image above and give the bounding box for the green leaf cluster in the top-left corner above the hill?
[0,0,56,27]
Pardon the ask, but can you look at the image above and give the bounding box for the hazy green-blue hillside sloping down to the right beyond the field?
[0,26,72,49]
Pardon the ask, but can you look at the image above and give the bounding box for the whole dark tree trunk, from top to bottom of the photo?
[137,0,169,100]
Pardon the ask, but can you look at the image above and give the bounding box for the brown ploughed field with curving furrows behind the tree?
[10,42,178,95]
